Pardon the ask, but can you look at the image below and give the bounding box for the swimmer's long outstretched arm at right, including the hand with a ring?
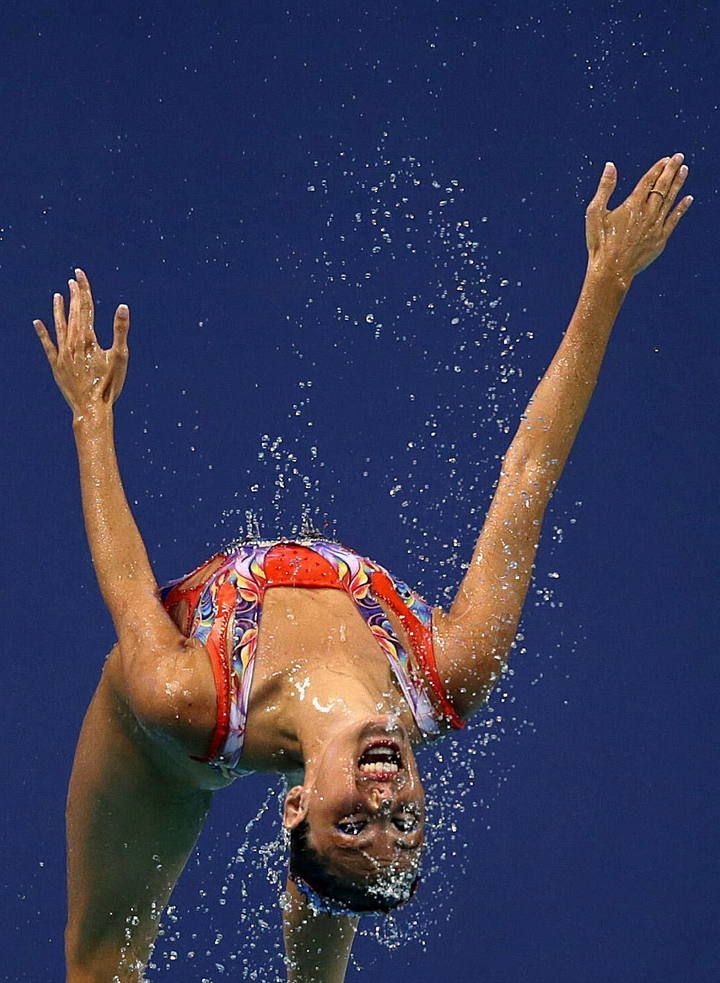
[435,154,692,715]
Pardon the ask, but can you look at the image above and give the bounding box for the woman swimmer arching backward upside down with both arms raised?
[34,154,692,983]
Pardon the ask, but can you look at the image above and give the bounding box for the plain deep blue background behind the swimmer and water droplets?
[0,0,720,983]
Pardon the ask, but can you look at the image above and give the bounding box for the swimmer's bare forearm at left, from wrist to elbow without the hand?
[73,403,158,636]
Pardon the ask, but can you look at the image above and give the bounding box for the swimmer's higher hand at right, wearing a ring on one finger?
[585,154,693,287]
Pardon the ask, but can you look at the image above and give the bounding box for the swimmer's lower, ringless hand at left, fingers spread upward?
[33,269,130,419]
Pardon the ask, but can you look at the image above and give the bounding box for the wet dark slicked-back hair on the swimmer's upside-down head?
[290,819,420,915]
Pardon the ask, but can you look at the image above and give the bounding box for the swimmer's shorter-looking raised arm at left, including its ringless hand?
[33,270,187,676]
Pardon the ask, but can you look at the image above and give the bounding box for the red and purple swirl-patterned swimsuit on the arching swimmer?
[161,539,465,778]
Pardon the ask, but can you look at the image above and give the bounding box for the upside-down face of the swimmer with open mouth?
[290,717,425,881]
